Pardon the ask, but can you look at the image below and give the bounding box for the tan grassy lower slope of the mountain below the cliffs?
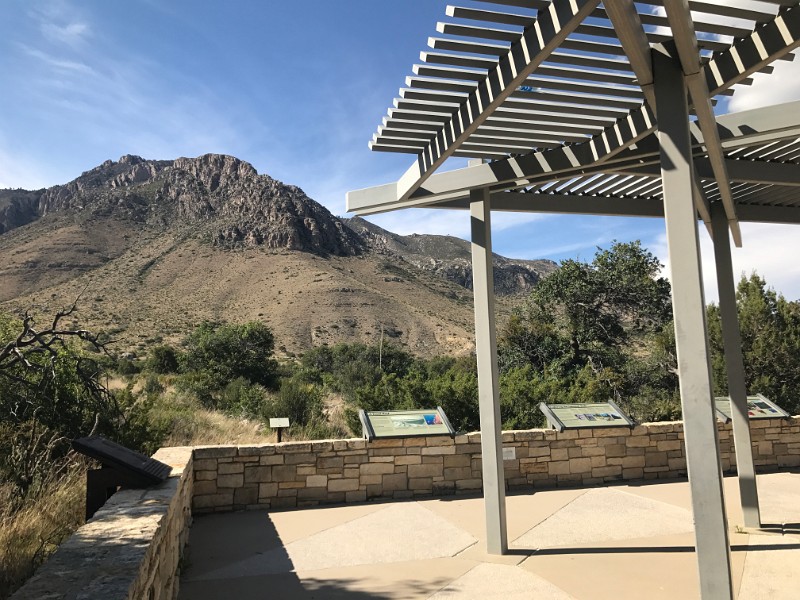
[0,232,482,357]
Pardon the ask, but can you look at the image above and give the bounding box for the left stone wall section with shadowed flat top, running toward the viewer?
[11,448,193,600]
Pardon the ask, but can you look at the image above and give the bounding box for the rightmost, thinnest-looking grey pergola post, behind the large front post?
[711,205,761,527]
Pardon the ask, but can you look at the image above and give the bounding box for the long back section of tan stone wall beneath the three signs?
[193,417,800,513]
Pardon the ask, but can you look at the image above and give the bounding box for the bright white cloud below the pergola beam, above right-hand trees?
[653,223,800,303]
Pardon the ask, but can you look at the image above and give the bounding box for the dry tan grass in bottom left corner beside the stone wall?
[0,465,86,600]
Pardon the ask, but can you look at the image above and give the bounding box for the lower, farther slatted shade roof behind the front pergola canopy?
[428,102,800,223]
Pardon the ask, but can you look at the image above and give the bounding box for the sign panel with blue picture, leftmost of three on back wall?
[358,406,456,440]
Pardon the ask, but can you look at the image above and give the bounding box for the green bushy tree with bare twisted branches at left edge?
[0,304,149,497]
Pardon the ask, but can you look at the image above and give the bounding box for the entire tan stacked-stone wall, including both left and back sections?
[12,417,800,600]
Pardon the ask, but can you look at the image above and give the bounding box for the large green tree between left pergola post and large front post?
[499,241,677,426]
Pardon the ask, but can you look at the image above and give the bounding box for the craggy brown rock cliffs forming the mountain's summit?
[0,154,363,256]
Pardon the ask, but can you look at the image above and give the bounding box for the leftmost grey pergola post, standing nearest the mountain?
[470,188,508,554]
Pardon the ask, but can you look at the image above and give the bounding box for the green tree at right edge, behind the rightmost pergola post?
[708,273,800,414]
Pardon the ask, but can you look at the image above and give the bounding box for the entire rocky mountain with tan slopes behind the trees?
[0,154,555,354]
